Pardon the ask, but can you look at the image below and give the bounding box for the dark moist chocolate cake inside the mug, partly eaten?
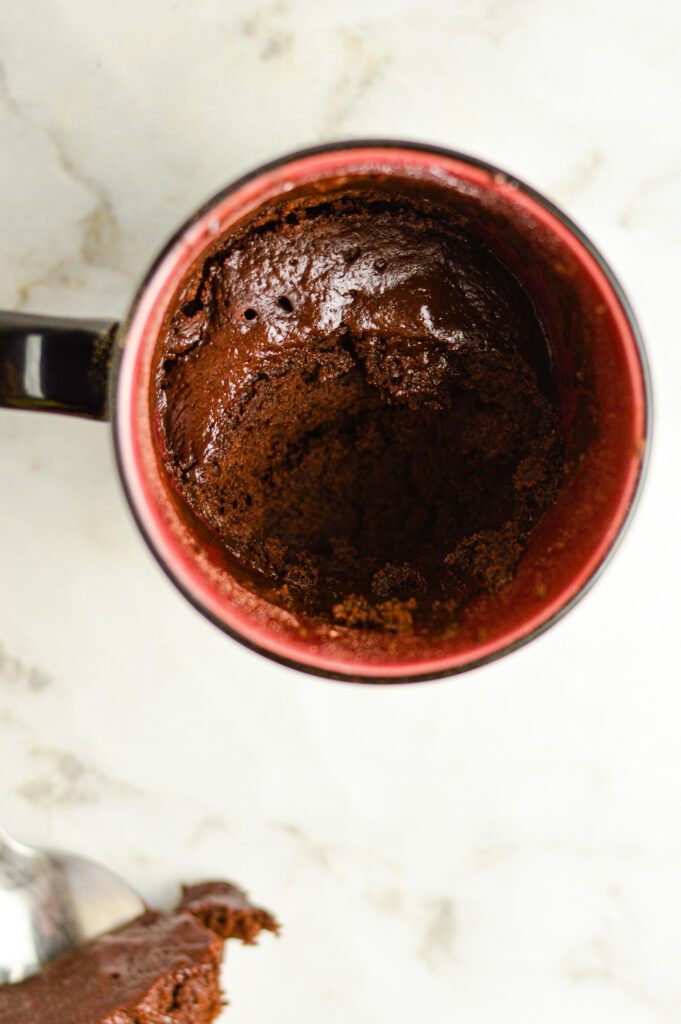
[153,188,562,631]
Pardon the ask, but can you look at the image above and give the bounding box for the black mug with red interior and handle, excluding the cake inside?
[0,140,650,682]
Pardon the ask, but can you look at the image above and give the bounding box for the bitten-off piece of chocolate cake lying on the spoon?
[0,882,279,1024]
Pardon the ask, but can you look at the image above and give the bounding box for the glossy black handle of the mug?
[0,311,118,420]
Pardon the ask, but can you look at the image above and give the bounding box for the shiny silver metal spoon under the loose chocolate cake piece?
[0,827,145,983]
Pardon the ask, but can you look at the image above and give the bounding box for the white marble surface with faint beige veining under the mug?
[0,0,681,1024]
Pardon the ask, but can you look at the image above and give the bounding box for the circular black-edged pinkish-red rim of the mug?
[112,137,652,684]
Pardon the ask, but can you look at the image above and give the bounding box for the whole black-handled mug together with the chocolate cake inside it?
[0,140,650,682]
